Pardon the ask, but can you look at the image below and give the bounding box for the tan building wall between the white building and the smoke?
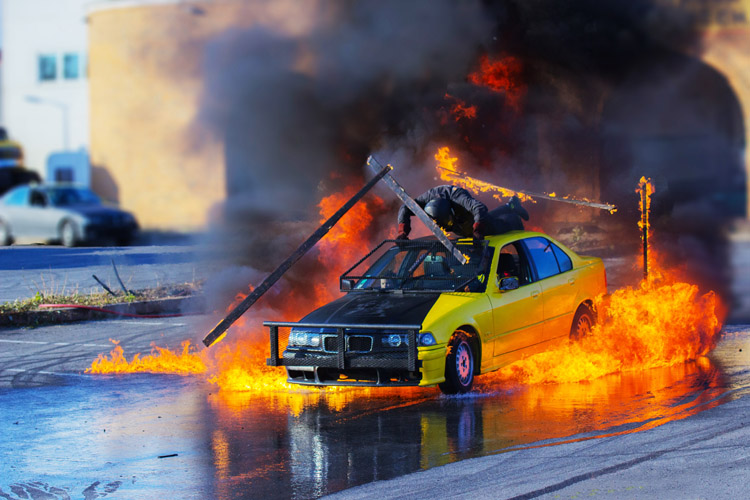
[88,0,318,230]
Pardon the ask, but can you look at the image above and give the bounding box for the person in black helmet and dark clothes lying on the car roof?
[396,185,529,240]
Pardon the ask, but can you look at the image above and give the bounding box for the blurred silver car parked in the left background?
[0,184,138,247]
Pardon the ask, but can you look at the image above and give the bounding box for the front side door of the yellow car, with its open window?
[488,242,544,365]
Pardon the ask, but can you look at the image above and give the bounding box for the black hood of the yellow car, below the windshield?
[300,292,440,325]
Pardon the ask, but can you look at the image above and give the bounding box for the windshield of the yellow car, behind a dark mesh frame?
[341,239,493,292]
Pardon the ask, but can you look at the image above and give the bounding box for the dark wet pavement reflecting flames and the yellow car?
[200,332,748,498]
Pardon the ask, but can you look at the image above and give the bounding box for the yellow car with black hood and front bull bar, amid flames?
[264,231,607,394]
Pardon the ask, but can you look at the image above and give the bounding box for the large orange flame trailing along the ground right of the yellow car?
[478,281,721,386]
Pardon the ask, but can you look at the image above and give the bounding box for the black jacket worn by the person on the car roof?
[398,185,487,238]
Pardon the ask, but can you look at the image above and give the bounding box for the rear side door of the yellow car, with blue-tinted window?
[524,236,577,340]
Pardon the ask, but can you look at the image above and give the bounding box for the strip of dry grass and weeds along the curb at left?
[0,282,203,314]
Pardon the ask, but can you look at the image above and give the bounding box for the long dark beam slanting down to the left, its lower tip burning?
[203,165,393,347]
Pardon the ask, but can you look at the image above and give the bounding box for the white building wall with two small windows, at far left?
[2,0,89,175]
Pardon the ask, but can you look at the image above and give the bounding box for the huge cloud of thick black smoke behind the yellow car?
[201,0,745,312]
